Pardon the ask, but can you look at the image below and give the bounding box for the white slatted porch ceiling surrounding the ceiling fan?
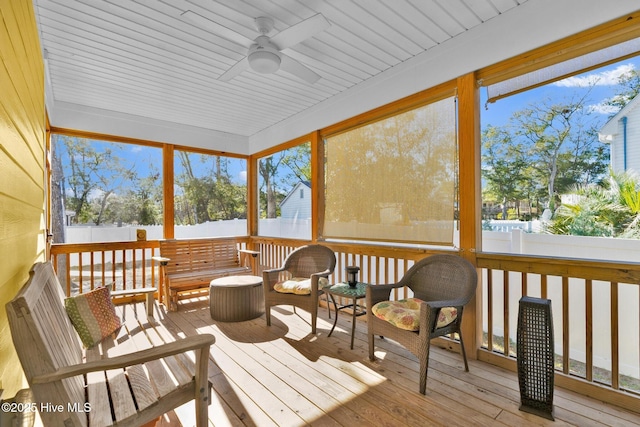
[34,0,638,154]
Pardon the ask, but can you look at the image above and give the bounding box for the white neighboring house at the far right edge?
[598,96,640,173]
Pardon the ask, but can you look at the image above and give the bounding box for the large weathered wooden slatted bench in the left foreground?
[6,263,215,427]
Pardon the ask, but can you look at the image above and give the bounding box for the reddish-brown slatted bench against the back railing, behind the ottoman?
[155,238,255,311]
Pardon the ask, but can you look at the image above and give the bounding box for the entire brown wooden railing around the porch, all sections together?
[52,237,640,410]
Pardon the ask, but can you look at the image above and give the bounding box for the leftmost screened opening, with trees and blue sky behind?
[51,134,163,243]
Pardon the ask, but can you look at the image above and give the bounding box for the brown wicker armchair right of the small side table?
[366,254,478,394]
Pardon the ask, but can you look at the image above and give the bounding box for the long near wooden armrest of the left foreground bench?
[31,334,216,384]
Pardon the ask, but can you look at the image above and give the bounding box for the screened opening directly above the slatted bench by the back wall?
[174,150,247,238]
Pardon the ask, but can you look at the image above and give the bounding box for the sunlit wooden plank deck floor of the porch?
[123,298,640,427]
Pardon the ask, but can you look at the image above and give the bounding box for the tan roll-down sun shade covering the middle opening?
[323,97,457,245]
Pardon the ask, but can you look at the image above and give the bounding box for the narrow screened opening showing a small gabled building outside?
[258,142,312,240]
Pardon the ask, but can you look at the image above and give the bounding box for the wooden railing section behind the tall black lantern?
[476,253,640,410]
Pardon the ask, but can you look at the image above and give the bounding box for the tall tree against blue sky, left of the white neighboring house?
[482,92,609,217]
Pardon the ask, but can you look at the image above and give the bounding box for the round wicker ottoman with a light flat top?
[209,276,264,322]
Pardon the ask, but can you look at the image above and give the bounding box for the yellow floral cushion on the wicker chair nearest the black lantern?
[371,298,458,331]
